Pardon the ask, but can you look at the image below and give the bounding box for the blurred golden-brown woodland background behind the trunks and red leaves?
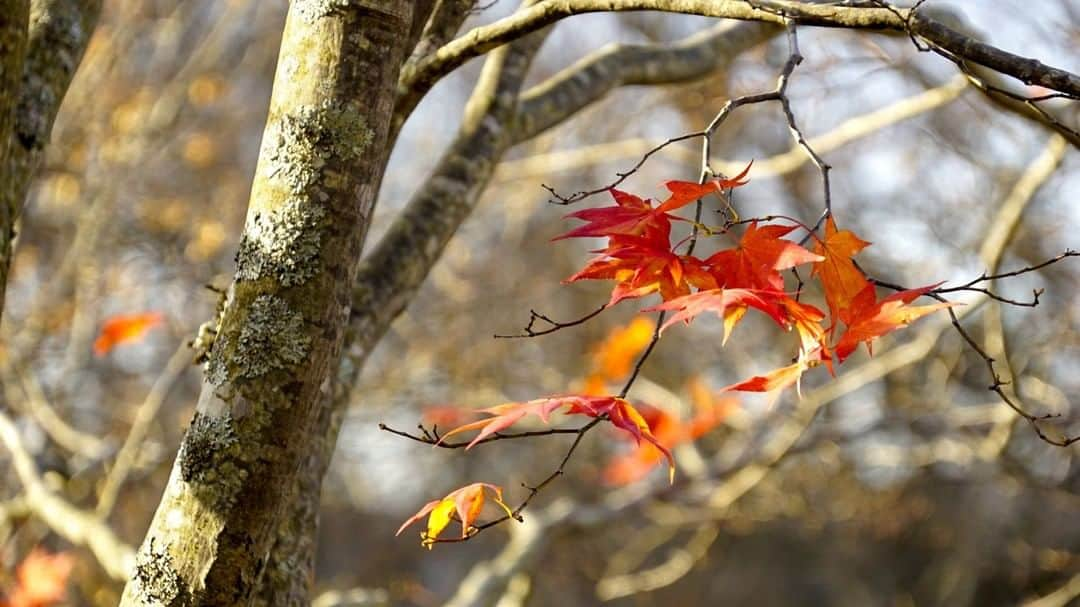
[0,0,1080,607]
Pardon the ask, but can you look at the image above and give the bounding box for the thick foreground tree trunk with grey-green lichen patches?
[122,0,414,606]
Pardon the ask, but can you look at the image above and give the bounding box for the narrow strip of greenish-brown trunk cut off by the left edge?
[0,0,30,319]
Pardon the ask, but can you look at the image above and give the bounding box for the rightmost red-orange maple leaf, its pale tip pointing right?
[836,283,955,363]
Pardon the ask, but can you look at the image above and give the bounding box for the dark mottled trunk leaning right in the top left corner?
[0,0,102,319]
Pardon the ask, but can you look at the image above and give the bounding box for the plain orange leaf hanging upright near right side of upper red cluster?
[810,216,870,324]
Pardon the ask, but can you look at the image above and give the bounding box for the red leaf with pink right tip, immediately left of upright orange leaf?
[705,221,823,291]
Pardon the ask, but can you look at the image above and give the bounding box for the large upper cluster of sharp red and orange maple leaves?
[558,170,947,392]
